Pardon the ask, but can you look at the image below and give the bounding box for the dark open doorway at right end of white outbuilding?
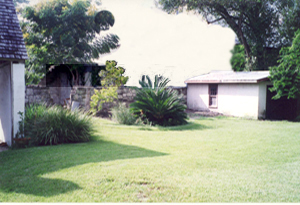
[266,85,297,120]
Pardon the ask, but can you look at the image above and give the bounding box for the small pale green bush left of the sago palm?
[111,103,137,125]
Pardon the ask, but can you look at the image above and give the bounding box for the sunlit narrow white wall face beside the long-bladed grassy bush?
[11,63,25,142]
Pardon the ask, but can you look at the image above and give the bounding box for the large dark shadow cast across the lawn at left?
[0,136,166,197]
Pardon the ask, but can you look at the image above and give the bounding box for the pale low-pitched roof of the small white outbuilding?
[185,71,270,84]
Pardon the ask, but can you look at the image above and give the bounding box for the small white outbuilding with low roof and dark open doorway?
[185,71,299,119]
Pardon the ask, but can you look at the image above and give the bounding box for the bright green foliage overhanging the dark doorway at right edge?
[270,30,300,99]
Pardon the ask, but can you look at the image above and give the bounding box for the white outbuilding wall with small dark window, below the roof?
[187,82,271,119]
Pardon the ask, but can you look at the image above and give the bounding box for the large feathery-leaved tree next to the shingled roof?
[21,0,119,82]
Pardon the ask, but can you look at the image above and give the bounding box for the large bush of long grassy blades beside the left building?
[24,105,92,145]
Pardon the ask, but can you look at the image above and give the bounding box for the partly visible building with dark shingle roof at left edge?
[0,0,28,146]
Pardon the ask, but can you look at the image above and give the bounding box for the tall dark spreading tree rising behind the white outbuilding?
[158,0,280,70]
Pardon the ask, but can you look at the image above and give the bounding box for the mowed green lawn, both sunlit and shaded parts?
[0,117,300,202]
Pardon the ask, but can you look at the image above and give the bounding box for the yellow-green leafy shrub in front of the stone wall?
[90,61,128,113]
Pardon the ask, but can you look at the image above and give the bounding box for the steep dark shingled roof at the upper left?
[0,0,28,60]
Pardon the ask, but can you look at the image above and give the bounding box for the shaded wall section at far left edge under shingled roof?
[0,62,12,145]
